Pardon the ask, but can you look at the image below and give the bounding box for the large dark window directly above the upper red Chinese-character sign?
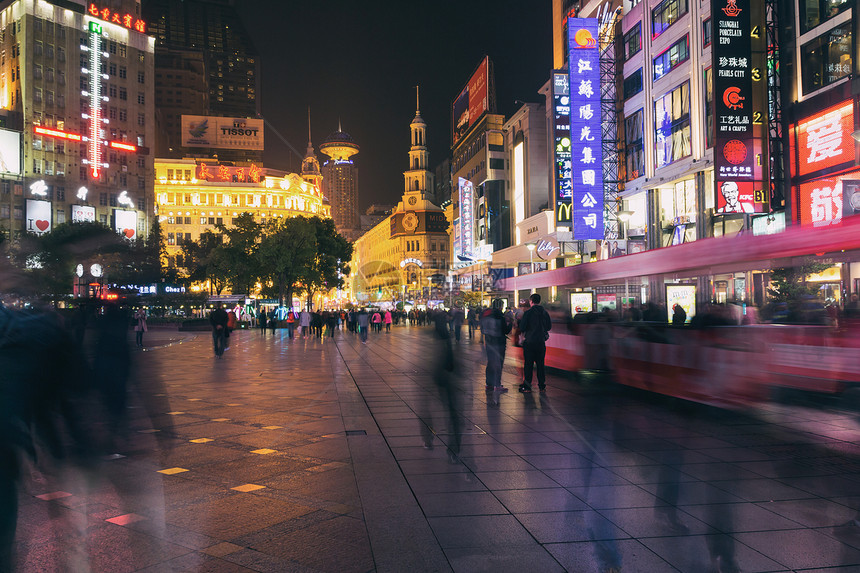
[800,23,852,94]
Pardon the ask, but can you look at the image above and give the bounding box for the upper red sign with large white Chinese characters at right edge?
[795,100,855,176]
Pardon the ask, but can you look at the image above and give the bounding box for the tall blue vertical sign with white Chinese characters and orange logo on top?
[556,18,604,240]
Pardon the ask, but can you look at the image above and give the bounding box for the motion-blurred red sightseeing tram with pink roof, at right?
[504,217,860,407]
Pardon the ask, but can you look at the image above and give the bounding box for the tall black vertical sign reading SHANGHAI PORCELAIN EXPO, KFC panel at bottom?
[711,0,768,213]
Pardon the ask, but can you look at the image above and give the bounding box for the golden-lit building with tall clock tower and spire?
[350,96,450,304]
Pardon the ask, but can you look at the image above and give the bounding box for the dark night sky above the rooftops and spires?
[236,0,552,212]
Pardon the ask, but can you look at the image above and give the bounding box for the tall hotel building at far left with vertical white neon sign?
[0,0,155,239]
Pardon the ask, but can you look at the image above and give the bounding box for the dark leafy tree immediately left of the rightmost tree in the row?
[257,217,317,306]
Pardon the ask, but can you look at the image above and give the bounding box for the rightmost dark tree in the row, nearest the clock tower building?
[299,217,352,303]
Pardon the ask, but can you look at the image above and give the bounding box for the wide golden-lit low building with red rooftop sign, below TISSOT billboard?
[155,159,331,267]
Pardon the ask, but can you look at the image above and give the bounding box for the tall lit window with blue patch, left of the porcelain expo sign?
[654,82,691,169]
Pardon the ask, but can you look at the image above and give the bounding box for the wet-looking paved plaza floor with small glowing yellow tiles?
[11,326,860,573]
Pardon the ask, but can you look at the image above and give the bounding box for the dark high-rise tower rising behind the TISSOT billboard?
[143,0,262,163]
